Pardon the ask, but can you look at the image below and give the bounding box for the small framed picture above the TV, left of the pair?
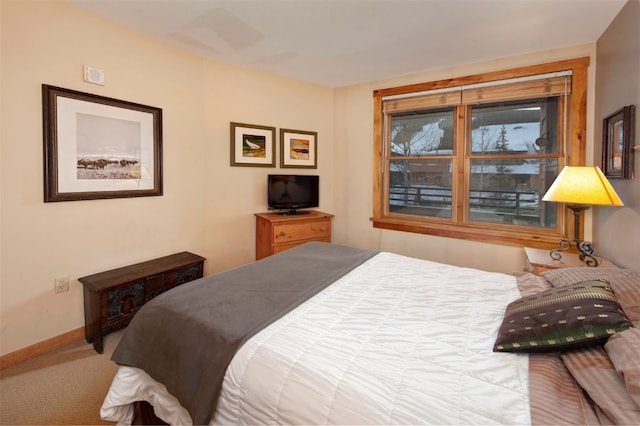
[231,122,276,167]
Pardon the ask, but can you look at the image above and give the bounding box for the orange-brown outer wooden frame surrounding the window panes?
[371,57,590,248]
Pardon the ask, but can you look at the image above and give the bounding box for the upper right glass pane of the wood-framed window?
[471,97,558,155]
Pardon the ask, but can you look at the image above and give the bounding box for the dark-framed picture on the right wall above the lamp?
[602,105,636,179]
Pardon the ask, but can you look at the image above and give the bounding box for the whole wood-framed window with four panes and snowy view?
[372,58,589,246]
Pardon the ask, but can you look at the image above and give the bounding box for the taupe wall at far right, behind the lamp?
[595,0,640,268]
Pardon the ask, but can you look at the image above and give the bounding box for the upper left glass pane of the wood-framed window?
[391,108,453,157]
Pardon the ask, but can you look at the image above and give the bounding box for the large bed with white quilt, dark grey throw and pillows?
[101,243,640,424]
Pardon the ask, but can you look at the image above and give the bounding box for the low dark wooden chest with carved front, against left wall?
[78,251,205,353]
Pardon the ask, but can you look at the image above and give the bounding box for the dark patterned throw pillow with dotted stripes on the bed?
[493,280,632,352]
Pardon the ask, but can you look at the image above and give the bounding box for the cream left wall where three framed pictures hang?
[0,0,334,355]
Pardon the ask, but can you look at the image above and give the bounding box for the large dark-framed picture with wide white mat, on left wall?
[42,84,162,203]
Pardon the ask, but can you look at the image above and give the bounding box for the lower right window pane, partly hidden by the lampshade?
[469,158,558,229]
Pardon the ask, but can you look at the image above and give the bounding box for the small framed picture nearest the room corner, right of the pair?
[280,129,318,169]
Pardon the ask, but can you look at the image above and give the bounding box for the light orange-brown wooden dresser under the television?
[256,210,333,260]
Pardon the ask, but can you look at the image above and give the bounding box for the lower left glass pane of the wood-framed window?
[389,158,451,218]
